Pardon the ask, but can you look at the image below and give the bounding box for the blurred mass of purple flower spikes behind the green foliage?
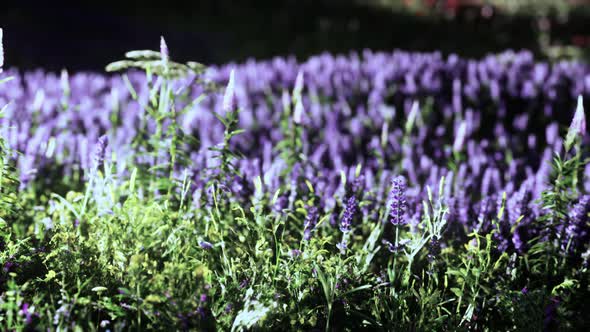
[0,51,590,255]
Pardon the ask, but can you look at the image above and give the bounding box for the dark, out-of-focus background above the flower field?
[0,0,590,71]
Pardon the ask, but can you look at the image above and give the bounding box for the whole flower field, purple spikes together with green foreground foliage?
[0,29,590,331]
